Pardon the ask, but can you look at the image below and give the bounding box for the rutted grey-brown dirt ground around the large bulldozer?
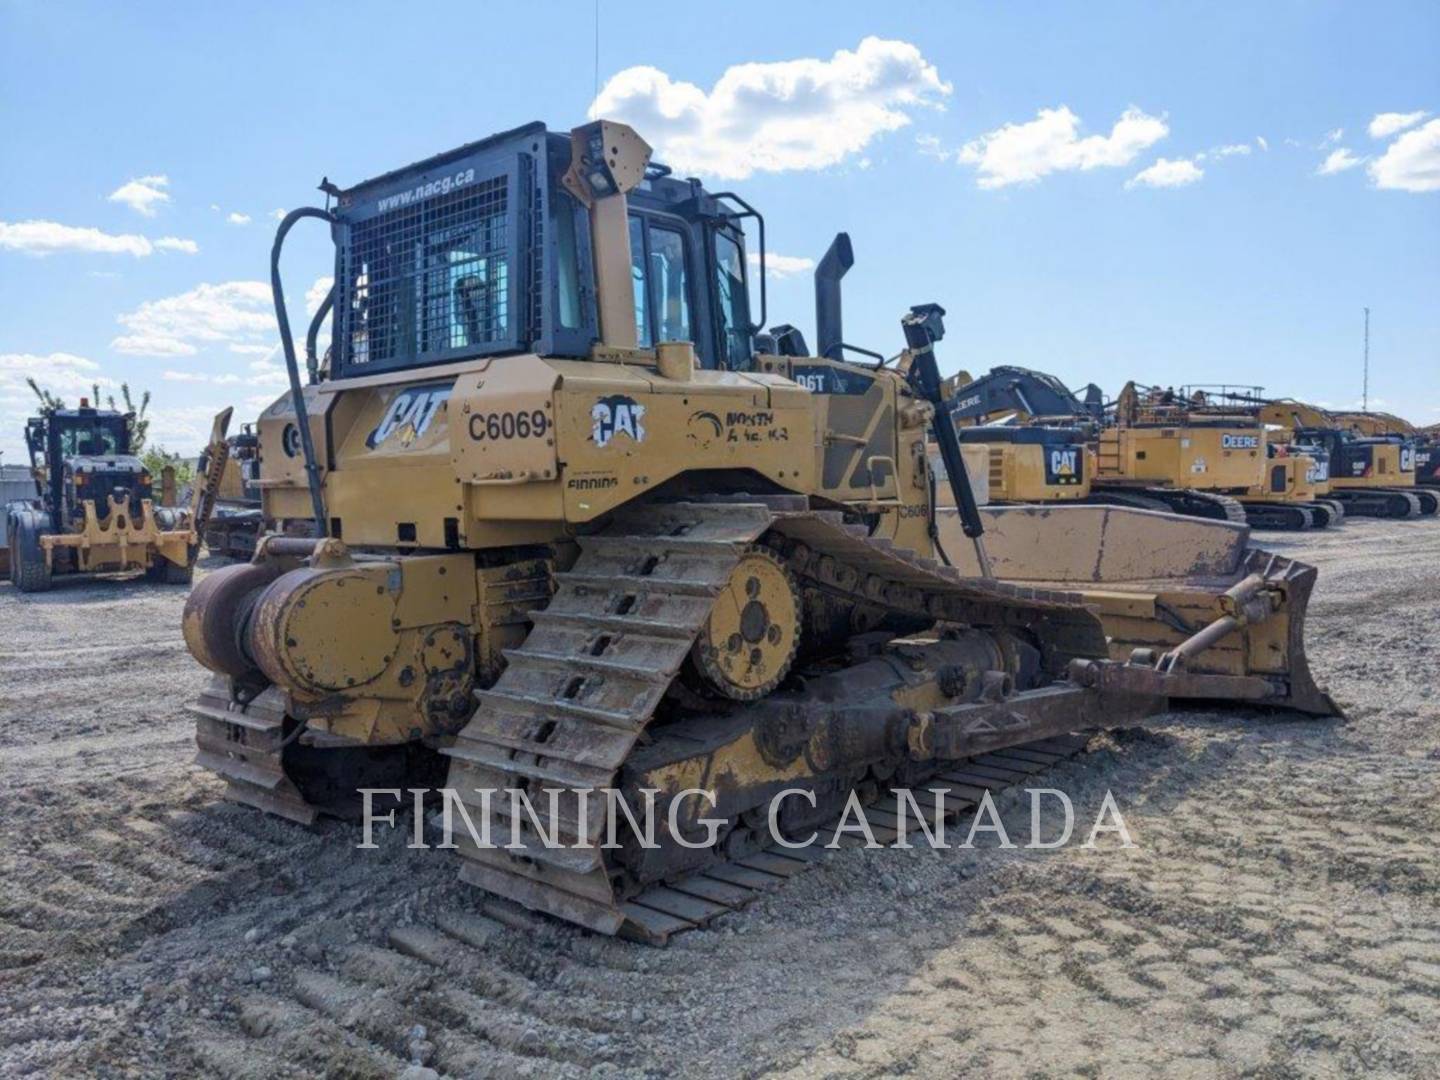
[0,520,1440,1077]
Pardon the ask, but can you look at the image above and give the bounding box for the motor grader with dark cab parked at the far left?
[0,397,230,592]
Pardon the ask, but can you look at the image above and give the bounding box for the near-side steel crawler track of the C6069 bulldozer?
[444,497,1106,942]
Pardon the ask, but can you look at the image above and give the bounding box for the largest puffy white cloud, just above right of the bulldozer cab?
[589,37,950,180]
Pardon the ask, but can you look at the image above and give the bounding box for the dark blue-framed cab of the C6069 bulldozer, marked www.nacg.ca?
[328,122,756,379]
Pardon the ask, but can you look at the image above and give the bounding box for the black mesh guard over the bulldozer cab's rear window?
[343,176,513,367]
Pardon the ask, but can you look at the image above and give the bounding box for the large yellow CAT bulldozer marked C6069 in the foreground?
[184,121,1333,942]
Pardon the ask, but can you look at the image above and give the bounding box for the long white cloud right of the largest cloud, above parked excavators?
[959,105,1169,189]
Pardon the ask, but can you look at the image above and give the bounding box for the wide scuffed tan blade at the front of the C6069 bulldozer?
[937,505,1339,716]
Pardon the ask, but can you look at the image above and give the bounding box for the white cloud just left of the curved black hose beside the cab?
[109,281,274,356]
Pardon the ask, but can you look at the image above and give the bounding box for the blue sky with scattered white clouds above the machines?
[0,0,1440,461]
